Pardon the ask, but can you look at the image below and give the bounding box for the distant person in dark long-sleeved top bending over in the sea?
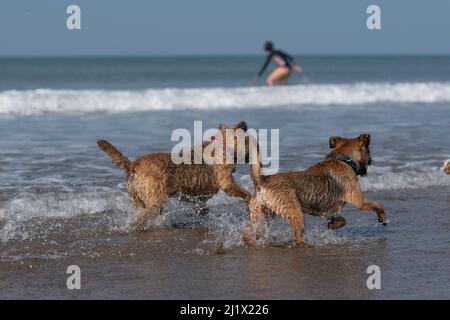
[255,41,302,87]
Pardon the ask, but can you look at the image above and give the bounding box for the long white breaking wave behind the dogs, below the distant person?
[0,82,450,115]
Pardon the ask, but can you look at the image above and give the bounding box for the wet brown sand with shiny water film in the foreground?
[0,188,450,299]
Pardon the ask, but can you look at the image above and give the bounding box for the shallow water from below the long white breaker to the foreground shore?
[0,105,450,299]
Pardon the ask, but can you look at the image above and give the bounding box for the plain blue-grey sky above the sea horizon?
[0,0,450,56]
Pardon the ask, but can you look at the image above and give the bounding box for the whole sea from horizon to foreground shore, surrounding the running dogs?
[0,56,450,299]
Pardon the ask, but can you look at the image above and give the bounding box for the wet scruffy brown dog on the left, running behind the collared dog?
[97,121,251,231]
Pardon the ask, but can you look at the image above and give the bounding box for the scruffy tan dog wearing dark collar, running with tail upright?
[244,134,387,244]
